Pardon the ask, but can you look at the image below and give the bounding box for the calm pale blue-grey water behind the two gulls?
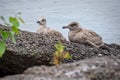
[0,0,120,44]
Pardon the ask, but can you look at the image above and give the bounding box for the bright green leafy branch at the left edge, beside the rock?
[0,13,24,58]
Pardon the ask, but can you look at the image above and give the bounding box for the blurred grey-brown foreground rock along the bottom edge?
[0,57,120,80]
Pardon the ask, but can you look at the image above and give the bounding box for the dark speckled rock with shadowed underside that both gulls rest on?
[0,25,120,76]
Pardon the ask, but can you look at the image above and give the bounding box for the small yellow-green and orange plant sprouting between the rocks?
[53,42,71,65]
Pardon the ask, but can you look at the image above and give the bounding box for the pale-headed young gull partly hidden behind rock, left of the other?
[36,18,66,41]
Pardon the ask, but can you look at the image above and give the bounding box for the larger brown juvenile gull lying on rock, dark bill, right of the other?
[63,22,104,48]
